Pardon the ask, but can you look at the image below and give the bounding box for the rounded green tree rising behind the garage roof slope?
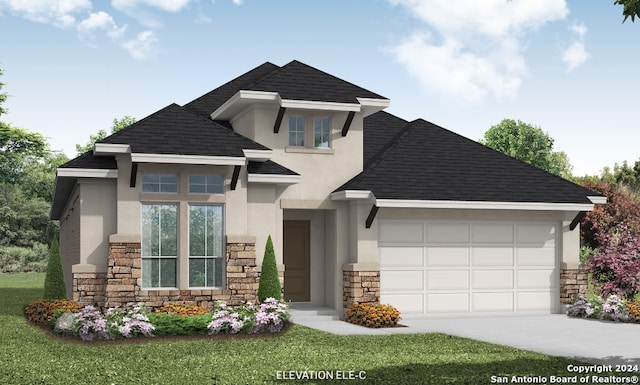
[480,119,572,178]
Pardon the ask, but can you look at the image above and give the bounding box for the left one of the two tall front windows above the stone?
[142,204,178,288]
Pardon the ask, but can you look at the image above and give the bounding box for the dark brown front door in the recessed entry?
[283,221,311,302]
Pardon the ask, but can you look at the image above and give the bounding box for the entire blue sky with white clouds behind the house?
[0,0,640,175]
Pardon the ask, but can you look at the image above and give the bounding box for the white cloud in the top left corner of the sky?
[0,0,91,28]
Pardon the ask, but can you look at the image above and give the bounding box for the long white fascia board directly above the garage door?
[376,199,594,211]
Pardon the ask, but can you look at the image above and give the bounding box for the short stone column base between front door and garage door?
[342,263,380,308]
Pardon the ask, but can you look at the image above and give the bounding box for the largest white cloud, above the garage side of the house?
[389,0,569,102]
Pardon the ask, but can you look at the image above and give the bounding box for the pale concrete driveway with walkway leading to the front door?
[292,309,640,365]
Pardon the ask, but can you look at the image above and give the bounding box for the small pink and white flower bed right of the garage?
[567,294,637,322]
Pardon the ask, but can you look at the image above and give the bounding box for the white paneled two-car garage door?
[378,220,559,315]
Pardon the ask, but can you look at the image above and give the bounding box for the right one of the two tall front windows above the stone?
[189,204,224,287]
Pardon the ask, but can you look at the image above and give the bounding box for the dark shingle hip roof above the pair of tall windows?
[100,104,268,157]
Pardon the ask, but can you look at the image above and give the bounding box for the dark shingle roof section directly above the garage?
[336,113,598,203]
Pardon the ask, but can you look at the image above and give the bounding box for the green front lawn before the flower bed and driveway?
[0,274,592,385]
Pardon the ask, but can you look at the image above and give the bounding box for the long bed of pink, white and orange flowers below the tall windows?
[25,298,290,341]
